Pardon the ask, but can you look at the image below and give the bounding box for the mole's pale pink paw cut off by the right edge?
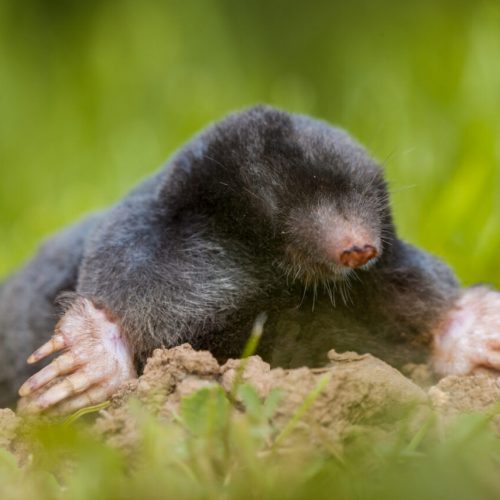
[432,286,500,375]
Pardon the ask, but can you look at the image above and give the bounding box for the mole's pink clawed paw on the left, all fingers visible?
[19,298,137,414]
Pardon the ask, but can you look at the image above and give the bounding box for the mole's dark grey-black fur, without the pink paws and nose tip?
[0,107,457,406]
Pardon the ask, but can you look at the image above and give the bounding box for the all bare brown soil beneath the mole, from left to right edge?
[0,344,500,458]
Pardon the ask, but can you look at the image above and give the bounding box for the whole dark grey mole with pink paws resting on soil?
[0,106,500,413]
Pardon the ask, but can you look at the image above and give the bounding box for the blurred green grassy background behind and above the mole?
[0,0,500,286]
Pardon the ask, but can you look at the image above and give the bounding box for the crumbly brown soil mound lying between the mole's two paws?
[96,344,427,451]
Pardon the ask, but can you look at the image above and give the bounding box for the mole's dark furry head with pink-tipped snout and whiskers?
[215,107,394,283]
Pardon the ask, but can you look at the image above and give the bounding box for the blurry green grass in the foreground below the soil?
[0,385,500,500]
